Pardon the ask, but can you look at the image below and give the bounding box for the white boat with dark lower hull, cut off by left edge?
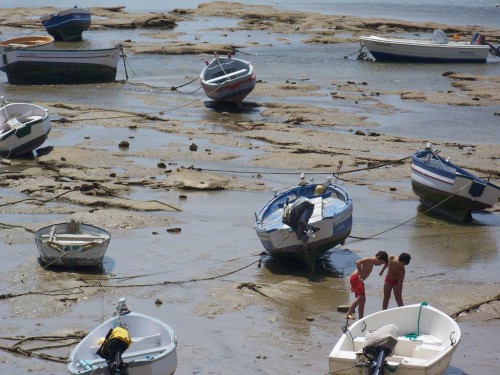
[0,103,51,155]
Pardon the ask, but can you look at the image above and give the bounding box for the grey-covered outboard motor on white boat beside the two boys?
[363,324,399,375]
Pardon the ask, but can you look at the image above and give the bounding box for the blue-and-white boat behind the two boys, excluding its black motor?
[255,175,353,272]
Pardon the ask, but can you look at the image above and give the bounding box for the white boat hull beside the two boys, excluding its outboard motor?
[329,304,461,375]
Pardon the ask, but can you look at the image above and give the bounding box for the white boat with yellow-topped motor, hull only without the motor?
[68,304,177,375]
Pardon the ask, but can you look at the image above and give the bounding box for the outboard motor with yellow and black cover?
[97,327,132,375]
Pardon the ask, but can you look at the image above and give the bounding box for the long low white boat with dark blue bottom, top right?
[359,36,490,62]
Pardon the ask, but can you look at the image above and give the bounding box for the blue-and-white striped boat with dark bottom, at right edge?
[411,143,500,221]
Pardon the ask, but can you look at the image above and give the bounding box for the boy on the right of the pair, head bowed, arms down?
[381,253,411,310]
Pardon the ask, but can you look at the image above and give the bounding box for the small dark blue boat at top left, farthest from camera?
[40,6,91,42]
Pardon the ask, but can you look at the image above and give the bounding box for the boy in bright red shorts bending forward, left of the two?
[346,251,388,319]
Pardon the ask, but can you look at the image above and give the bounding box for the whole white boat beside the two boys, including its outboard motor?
[328,302,461,375]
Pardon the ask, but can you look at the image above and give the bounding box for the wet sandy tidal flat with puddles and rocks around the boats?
[0,2,500,375]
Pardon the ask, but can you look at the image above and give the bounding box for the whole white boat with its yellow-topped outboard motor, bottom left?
[68,298,177,375]
